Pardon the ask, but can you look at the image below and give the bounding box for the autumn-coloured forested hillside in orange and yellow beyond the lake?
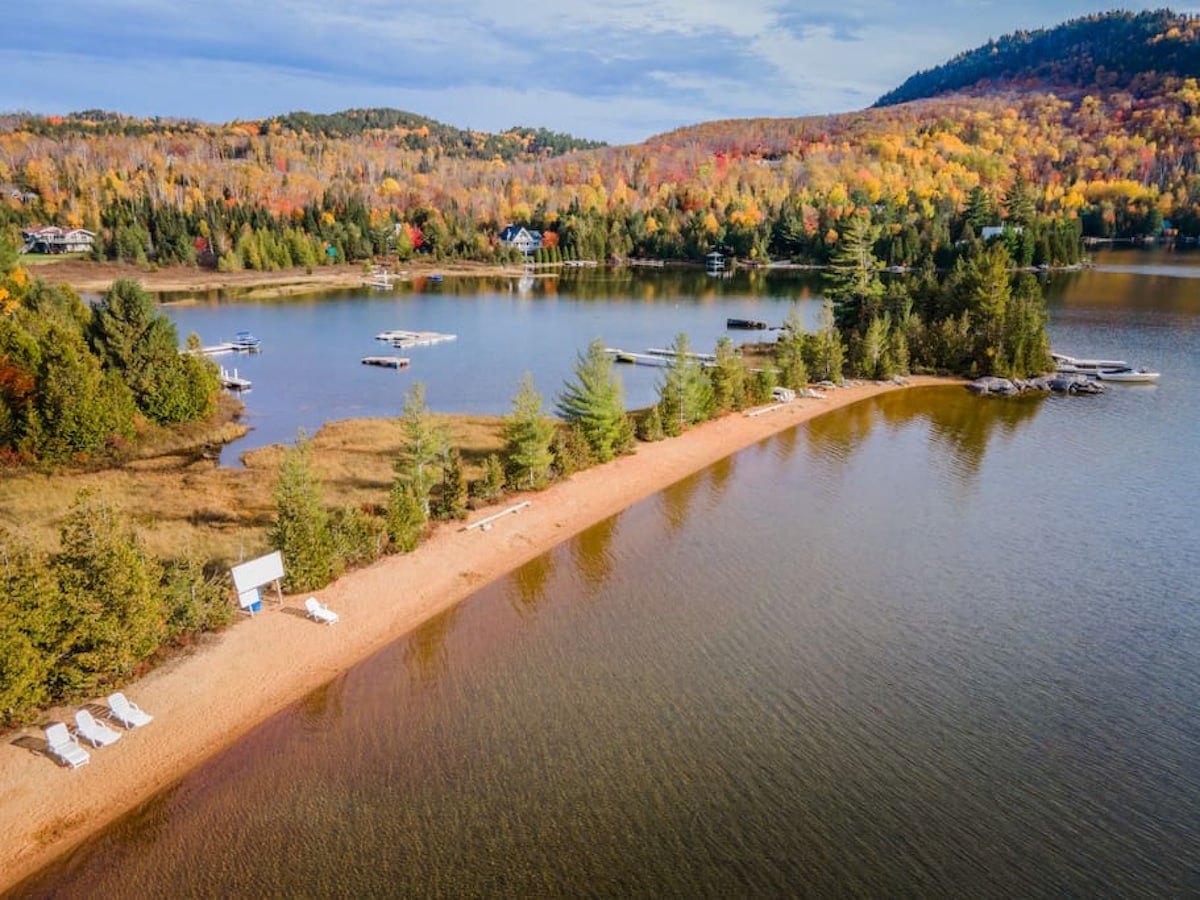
[0,13,1200,269]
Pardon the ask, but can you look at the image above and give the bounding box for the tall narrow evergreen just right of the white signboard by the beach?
[269,431,334,592]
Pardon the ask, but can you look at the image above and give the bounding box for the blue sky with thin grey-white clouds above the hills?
[0,0,1194,144]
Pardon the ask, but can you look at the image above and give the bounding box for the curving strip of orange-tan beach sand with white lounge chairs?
[0,378,946,890]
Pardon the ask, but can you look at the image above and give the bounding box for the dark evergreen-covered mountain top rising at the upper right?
[875,10,1200,107]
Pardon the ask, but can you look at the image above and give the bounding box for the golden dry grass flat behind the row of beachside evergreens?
[0,415,503,562]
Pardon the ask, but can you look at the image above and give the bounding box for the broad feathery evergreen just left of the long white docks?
[556,338,632,466]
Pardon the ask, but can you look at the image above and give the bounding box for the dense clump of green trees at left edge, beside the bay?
[0,240,220,464]
